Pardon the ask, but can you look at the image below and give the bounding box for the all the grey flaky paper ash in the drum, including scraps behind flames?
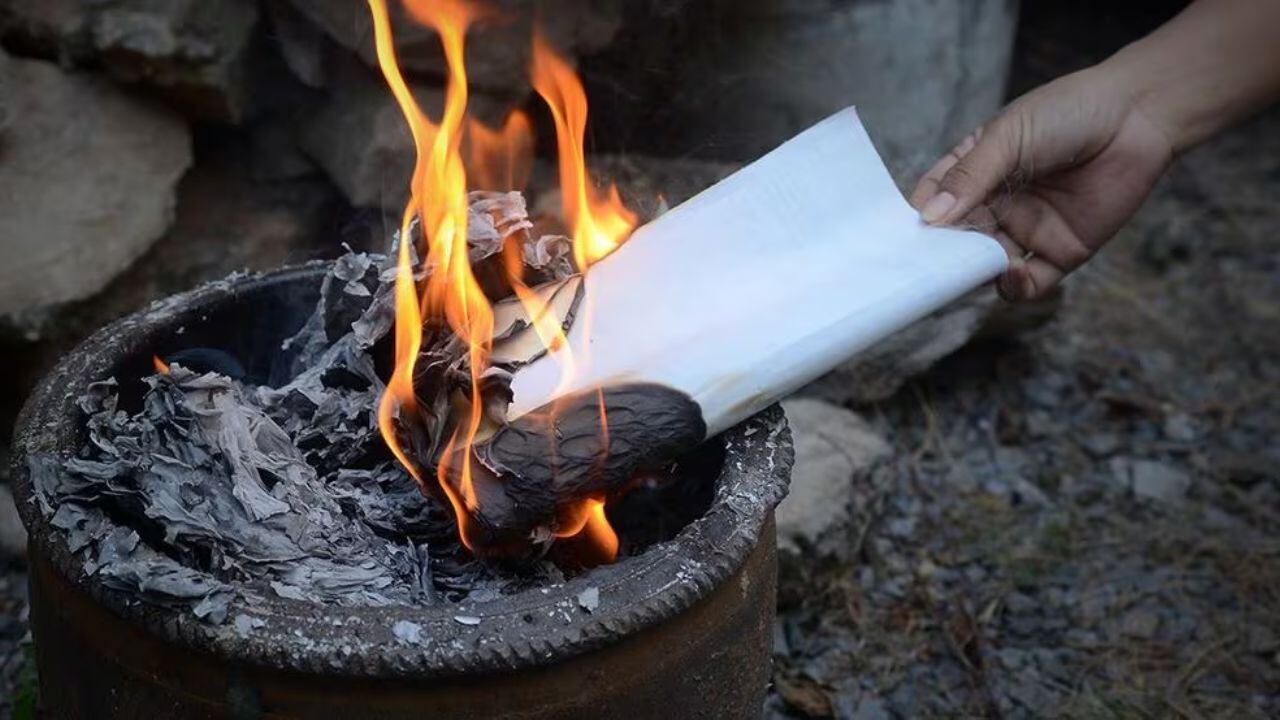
[29,192,572,623]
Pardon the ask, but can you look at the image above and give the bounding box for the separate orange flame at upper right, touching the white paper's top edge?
[530,31,636,270]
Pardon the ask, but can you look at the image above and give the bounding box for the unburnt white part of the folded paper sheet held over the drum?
[509,108,1006,434]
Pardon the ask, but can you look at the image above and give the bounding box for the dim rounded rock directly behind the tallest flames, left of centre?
[301,57,506,211]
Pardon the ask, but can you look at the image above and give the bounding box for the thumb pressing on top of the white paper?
[920,115,1020,225]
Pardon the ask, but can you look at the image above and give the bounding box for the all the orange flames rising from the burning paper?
[367,0,635,562]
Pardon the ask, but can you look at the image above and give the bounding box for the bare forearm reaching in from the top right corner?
[1096,0,1280,152]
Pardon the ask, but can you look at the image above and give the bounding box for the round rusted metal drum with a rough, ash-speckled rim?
[14,265,792,719]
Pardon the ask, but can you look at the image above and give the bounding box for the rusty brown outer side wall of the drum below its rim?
[31,524,777,720]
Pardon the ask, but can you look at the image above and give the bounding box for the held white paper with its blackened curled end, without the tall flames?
[447,109,1006,547]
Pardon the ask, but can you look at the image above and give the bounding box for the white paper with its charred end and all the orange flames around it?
[355,0,1005,560]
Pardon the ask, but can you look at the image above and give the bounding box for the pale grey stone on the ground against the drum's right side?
[777,397,890,552]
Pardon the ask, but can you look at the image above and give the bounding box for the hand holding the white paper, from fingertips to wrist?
[911,65,1174,300]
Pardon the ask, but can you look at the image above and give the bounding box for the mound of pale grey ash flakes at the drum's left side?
[29,365,417,621]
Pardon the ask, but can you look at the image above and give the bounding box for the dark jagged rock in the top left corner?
[0,0,257,122]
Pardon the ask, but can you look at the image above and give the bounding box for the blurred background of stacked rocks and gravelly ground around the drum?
[0,0,1280,719]
